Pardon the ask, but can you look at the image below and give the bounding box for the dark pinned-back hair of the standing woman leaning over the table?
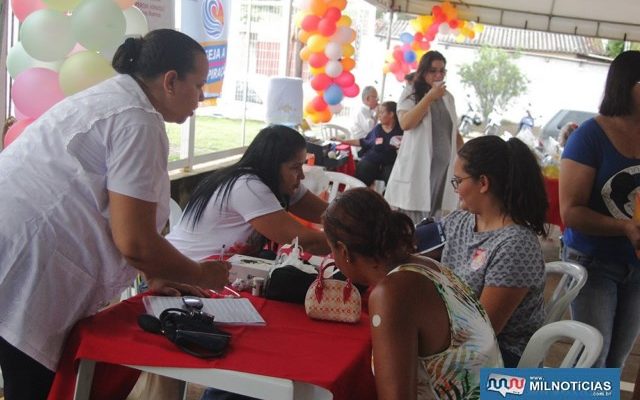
[111,29,205,79]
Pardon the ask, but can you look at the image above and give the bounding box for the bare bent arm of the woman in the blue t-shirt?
[560,158,640,244]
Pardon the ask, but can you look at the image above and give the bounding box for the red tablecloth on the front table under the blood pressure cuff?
[49,295,376,400]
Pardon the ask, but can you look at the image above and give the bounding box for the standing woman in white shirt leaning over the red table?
[0,29,229,400]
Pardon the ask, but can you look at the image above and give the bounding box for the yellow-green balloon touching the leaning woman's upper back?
[59,51,116,96]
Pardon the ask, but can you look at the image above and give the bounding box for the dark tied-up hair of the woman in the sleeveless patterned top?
[322,188,415,261]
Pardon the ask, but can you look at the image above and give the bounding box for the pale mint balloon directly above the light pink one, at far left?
[20,9,76,61]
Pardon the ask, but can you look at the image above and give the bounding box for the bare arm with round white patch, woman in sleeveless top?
[369,277,418,400]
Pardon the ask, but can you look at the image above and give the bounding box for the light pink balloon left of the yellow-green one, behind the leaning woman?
[11,68,64,118]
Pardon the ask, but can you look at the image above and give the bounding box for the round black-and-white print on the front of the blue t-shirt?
[600,165,640,219]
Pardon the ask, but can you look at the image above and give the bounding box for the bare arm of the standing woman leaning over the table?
[109,191,230,289]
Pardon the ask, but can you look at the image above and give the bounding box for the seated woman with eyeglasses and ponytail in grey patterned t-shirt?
[441,136,548,367]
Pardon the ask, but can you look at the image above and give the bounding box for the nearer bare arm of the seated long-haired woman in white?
[249,208,331,255]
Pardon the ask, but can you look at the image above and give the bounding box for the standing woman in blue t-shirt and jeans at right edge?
[560,51,640,368]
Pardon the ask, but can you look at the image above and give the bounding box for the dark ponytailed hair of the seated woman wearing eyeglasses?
[458,136,549,236]
